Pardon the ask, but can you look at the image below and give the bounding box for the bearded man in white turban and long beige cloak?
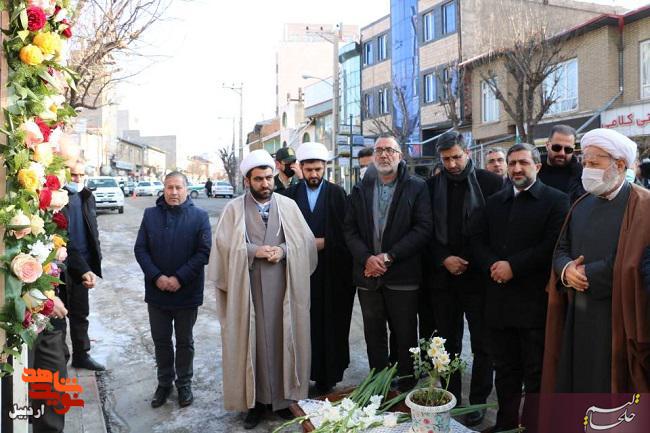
[208,150,317,429]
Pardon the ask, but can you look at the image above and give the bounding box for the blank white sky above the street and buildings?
[120,0,648,160]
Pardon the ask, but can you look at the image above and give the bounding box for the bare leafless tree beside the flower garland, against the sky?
[67,0,172,109]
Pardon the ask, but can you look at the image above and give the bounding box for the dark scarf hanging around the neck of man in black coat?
[433,159,485,245]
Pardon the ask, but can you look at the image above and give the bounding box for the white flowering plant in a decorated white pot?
[406,337,466,433]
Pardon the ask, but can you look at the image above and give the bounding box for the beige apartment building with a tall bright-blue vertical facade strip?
[361,0,617,162]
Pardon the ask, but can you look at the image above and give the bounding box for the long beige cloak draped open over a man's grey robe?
[207,194,318,411]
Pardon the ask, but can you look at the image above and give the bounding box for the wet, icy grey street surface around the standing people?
[85,197,494,433]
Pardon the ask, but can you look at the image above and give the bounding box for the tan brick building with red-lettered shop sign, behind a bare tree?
[463,6,650,154]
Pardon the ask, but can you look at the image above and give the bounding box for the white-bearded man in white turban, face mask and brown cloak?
[542,129,650,393]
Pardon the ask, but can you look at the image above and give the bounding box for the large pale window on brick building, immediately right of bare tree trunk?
[544,59,578,114]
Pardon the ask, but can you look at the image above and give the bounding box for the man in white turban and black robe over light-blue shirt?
[282,143,355,393]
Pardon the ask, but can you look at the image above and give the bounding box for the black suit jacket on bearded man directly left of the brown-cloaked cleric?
[473,179,569,328]
